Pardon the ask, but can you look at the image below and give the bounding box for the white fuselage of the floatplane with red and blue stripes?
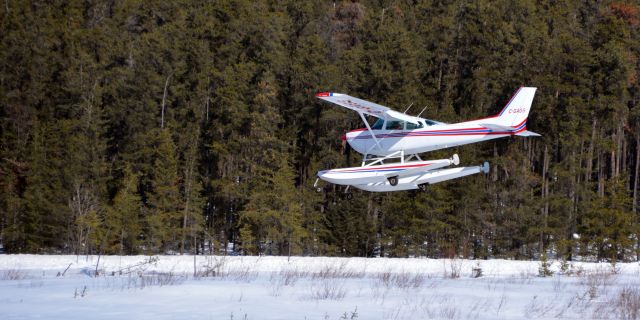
[345,119,526,156]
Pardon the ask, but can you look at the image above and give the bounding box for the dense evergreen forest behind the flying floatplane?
[0,0,640,261]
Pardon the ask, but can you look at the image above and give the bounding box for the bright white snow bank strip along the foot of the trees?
[0,255,639,277]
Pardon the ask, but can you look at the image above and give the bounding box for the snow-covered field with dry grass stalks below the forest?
[0,255,640,320]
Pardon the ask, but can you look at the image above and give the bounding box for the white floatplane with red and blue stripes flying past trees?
[314,87,540,198]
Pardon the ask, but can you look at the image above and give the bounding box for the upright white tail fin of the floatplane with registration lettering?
[496,87,537,130]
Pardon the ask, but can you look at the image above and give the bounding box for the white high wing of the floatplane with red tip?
[316,92,418,124]
